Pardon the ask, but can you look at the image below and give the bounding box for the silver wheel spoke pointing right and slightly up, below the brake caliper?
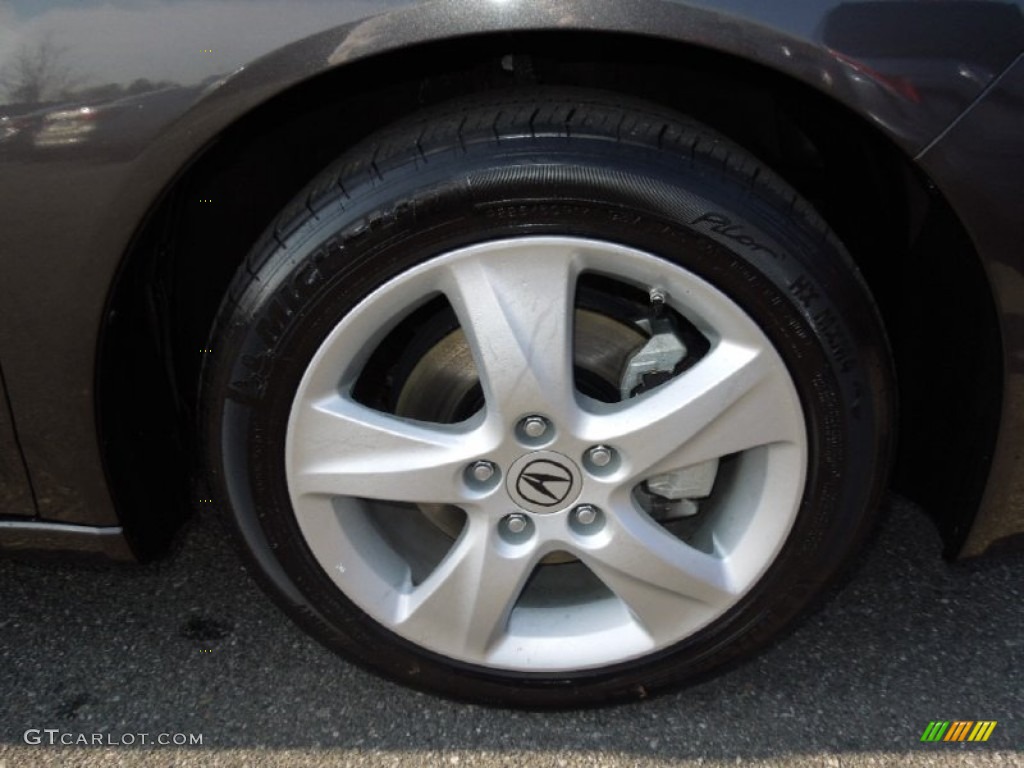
[587,343,802,478]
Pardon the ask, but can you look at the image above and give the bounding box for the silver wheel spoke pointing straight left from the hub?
[290,396,483,504]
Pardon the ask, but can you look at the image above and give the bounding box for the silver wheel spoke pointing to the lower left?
[398,520,536,657]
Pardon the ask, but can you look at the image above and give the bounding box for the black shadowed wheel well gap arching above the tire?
[97,33,1001,557]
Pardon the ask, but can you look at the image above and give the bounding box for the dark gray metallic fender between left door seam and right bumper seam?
[0,0,1024,552]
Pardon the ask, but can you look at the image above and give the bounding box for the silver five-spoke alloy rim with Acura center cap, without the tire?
[286,237,807,672]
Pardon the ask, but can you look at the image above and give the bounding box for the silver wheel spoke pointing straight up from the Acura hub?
[442,245,578,423]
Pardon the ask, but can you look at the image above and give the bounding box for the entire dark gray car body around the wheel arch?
[0,0,1024,558]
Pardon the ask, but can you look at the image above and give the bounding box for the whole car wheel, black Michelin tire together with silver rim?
[203,89,892,707]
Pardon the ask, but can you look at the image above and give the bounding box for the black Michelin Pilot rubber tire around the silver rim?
[202,89,893,708]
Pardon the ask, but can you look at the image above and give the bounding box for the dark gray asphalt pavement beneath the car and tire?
[0,500,1024,768]
